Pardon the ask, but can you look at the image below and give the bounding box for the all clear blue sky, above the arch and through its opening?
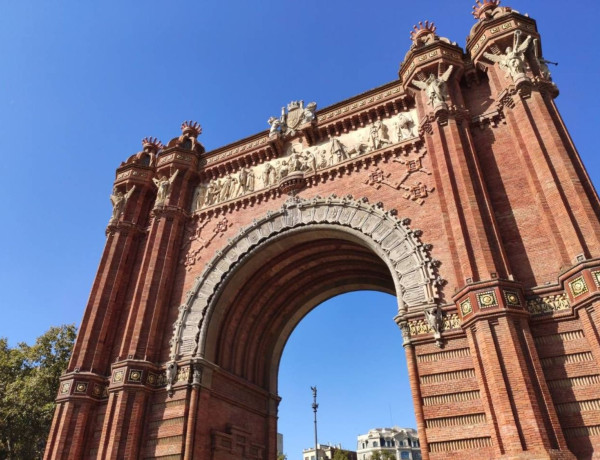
[0,0,600,460]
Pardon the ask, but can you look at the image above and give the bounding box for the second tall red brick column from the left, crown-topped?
[101,123,204,458]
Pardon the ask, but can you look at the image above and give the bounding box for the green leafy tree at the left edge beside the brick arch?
[0,325,76,459]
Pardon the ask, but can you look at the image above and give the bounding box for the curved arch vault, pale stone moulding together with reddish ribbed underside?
[171,196,437,392]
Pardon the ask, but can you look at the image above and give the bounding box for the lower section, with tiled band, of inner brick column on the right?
[454,281,574,458]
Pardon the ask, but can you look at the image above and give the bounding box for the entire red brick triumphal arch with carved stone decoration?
[46,0,600,460]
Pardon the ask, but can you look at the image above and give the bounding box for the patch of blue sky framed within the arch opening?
[277,291,416,459]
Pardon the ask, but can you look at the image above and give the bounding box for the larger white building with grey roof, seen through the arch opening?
[356,426,421,460]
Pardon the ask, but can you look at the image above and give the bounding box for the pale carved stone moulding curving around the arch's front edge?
[170,195,439,361]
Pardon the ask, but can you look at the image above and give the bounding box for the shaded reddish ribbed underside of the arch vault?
[205,230,395,392]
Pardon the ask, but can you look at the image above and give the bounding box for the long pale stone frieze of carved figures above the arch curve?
[195,112,420,212]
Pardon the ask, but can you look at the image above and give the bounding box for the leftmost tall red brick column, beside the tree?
[45,139,160,459]
